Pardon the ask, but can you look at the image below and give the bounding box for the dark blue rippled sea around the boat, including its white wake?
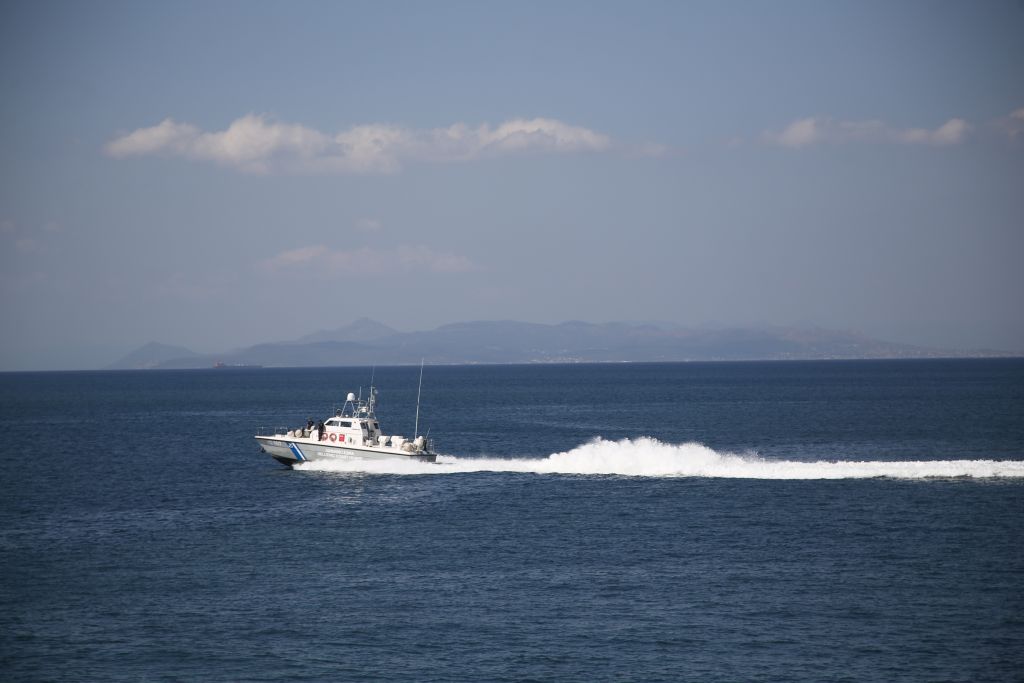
[0,358,1024,682]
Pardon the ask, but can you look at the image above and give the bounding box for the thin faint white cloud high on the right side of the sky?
[762,117,971,147]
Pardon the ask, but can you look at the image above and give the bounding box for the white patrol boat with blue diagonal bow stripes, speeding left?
[256,387,437,467]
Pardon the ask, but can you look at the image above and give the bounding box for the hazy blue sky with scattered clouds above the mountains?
[0,0,1024,370]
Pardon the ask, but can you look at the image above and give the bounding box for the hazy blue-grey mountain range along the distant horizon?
[110,317,999,370]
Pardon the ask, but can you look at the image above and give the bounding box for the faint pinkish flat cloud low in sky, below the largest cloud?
[259,245,480,276]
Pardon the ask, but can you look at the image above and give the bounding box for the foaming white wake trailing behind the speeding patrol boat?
[296,437,1024,479]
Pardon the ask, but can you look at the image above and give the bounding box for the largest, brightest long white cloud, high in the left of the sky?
[105,115,612,173]
